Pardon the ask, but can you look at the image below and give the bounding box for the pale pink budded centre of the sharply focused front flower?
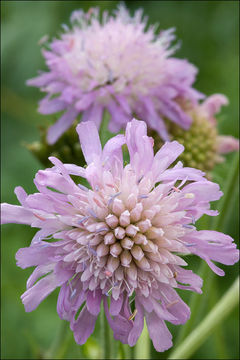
[68,175,189,299]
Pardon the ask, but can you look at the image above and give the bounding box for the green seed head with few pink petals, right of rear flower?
[149,94,239,172]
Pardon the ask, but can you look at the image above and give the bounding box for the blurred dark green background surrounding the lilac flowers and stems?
[1,0,239,359]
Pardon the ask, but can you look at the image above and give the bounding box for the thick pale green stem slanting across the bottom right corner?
[168,277,239,359]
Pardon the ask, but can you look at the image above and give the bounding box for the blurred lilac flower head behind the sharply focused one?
[28,5,201,144]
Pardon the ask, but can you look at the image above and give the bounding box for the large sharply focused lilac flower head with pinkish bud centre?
[2,120,239,351]
